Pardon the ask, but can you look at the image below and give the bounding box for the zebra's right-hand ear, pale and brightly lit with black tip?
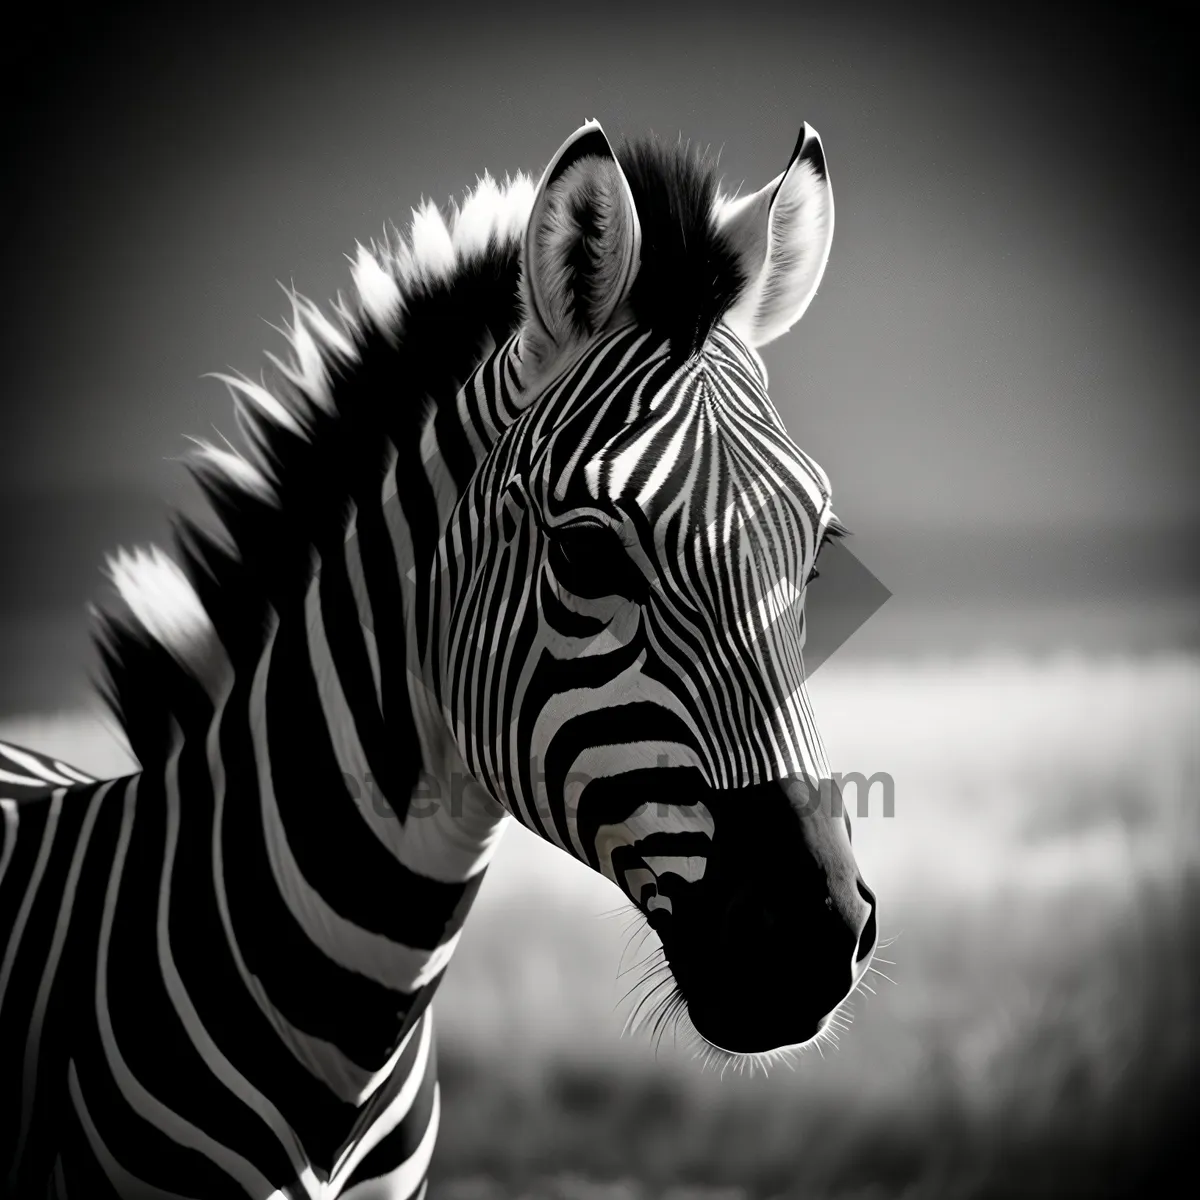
[718,122,833,346]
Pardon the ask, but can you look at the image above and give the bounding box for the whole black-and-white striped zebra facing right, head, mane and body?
[0,121,877,1200]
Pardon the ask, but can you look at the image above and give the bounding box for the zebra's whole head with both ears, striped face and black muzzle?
[434,122,876,1052]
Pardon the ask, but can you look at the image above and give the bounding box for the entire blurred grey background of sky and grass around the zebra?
[0,0,1200,1200]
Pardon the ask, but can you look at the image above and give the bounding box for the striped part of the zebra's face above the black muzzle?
[422,325,832,899]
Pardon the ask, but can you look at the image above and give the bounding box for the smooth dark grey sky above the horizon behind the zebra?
[0,2,1200,700]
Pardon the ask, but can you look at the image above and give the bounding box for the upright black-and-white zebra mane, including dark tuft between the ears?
[94,139,744,766]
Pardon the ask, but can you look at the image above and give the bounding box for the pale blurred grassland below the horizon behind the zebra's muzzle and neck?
[0,655,1200,1200]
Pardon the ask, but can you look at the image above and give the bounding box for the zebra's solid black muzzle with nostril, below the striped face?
[652,779,877,1054]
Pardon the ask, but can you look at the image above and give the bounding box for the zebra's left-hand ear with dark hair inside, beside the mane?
[521,121,642,356]
